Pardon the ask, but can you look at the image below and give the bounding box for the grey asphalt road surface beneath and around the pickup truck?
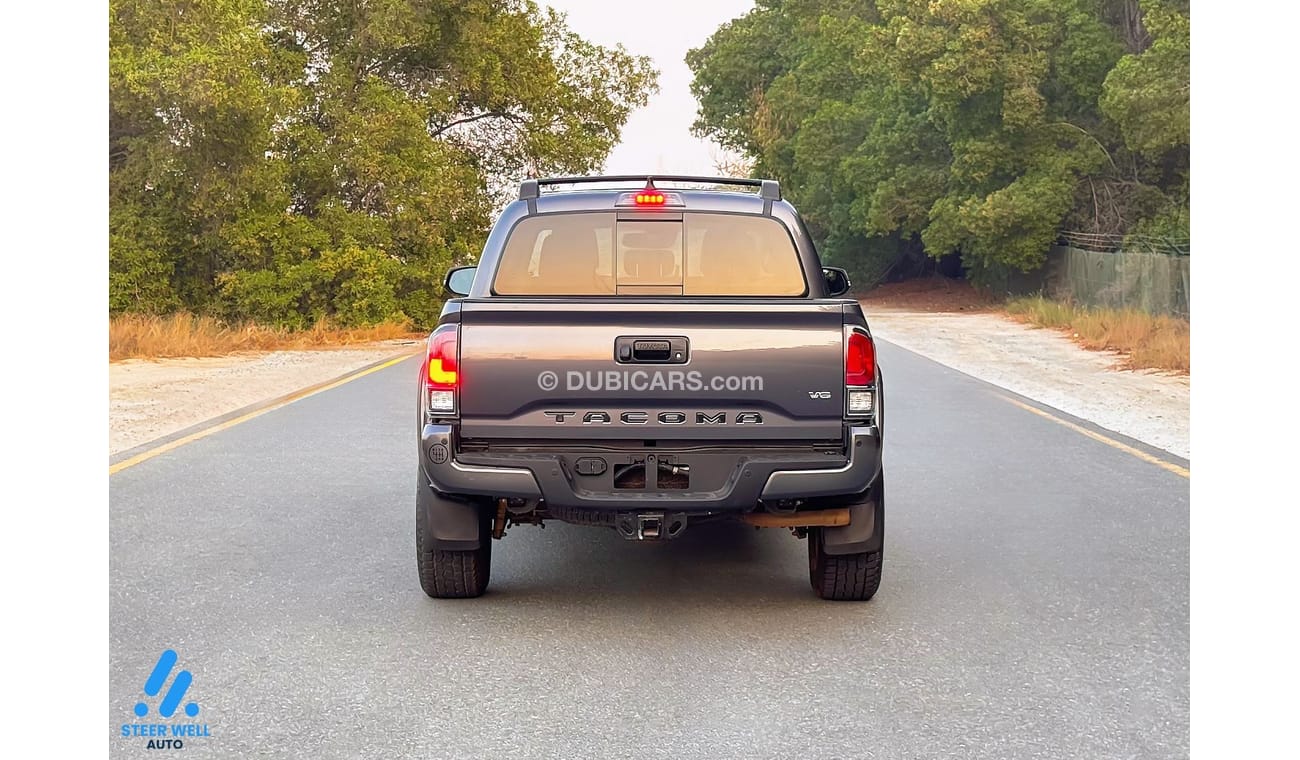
[108,343,1188,759]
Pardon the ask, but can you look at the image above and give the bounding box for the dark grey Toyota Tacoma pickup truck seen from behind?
[416,175,884,600]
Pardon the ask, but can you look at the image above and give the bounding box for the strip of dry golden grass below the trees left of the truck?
[108,314,423,361]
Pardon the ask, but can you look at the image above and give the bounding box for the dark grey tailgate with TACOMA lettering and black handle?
[460,296,844,442]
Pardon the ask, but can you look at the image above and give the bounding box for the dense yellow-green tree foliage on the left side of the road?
[109,0,657,327]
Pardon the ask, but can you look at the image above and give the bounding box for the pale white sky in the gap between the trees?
[541,0,754,174]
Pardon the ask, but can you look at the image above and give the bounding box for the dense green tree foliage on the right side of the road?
[686,0,1191,282]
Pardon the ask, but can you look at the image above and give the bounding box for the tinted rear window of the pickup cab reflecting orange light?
[493,212,807,296]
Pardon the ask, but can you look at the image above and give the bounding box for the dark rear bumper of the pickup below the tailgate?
[420,425,880,512]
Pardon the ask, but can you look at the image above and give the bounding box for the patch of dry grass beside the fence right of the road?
[1006,296,1192,374]
